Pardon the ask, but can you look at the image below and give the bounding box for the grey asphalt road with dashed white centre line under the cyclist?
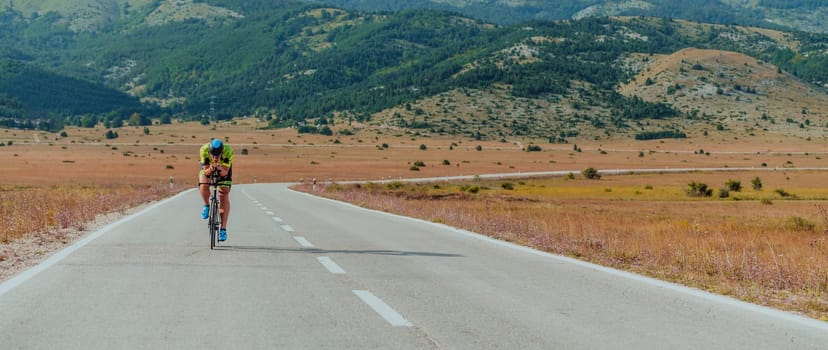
[0,184,828,349]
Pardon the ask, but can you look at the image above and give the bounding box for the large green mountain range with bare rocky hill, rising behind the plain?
[0,0,828,142]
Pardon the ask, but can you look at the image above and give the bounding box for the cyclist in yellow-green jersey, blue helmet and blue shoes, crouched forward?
[198,139,233,241]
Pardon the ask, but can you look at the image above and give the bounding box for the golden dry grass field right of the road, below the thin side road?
[308,171,828,321]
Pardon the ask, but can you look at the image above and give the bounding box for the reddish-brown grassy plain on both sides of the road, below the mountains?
[0,118,828,320]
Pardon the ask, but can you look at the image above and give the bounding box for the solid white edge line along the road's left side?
[0,189,195,296]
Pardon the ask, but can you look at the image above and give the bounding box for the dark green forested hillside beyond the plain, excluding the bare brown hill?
[0,0,828,140]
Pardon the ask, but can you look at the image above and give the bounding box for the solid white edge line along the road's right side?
[288,188,828,331]
